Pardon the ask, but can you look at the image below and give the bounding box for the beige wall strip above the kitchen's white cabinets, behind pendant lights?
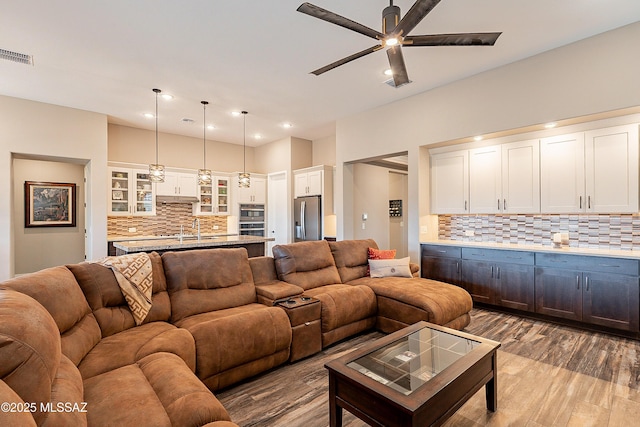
[108,124,254,172]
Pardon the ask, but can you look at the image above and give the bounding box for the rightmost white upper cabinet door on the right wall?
[585,125,638,213]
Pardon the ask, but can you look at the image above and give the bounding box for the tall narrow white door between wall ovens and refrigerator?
[266,171,291,256]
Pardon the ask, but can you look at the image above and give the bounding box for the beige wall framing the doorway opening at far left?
[0,96,107,280]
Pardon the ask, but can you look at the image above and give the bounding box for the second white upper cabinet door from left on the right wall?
[469,145,502,213]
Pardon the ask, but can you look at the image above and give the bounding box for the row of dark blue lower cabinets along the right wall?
[422,245,640,338]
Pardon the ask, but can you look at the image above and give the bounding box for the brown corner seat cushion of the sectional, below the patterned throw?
[78,322,196,379]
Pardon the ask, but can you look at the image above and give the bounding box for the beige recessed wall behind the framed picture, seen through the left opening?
[13,159,85,274]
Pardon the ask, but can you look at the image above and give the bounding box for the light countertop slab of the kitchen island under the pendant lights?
[113,235,275,252]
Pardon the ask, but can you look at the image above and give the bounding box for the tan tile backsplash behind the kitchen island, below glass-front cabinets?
[107,203,227,237]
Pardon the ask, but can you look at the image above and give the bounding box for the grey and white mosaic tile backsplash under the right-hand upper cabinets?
[438,214,640,249]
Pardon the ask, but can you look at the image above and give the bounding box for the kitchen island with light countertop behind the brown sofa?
[113,236,275,257]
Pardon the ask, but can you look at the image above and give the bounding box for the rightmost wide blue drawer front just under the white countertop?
[536,253,638,276]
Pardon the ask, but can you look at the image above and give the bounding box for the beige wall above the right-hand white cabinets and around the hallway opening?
[336,22,640,262]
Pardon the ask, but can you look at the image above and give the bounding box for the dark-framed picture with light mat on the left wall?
[24,181,76,228]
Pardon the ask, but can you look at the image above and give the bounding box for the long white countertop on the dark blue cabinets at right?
[420,240,640,260]
